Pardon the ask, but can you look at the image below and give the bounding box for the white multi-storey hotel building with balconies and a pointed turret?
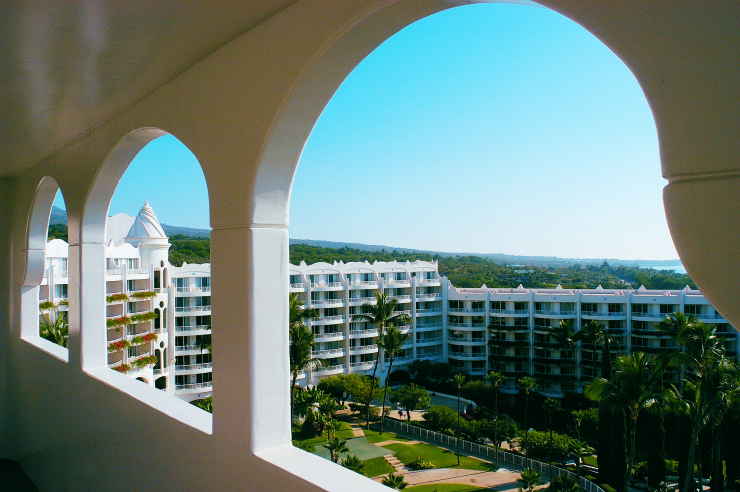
[40,204,740,401]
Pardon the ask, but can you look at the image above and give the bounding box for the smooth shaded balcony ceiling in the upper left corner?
[0,0,295,177]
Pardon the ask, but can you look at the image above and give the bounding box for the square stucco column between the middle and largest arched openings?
[211,226,291,452]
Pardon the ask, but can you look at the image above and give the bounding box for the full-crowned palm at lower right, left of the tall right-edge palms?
[585,352,671,492]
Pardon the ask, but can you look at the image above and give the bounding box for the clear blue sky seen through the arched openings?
[52,4,678,259]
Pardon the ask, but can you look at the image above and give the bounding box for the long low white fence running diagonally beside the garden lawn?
[385,417,604,492]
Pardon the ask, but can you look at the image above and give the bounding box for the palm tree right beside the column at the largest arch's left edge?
[288,293,326,422]
